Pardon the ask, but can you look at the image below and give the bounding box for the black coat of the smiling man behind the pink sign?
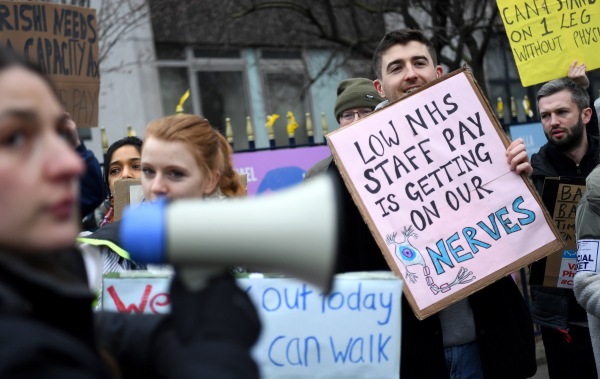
[328,162,537,379]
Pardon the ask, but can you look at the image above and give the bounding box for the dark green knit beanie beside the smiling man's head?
[334,78,383,122]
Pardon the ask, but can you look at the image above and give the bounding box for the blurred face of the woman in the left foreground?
[0,67,84,253]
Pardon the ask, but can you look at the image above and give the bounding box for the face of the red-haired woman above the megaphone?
[142,137,219,200]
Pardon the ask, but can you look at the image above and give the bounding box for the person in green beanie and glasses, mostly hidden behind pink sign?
[304,78,383,181]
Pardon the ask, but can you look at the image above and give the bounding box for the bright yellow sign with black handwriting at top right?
[497,0,600,87]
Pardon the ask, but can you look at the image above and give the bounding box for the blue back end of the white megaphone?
[119,199,167,264]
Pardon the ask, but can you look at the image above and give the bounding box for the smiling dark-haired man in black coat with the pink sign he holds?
[328,29,556,378]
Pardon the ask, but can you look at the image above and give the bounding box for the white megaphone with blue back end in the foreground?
[120,175,342,292]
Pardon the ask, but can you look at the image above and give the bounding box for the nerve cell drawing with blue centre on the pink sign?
[385,225,475,295]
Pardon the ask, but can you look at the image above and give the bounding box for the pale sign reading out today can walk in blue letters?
[103,272,402,378]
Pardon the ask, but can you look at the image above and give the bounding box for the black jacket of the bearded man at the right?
[530,134,600,330]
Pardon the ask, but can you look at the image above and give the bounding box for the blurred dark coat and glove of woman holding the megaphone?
[0,250,260,379]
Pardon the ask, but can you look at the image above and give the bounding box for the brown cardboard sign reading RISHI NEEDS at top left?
[0,1,100,127]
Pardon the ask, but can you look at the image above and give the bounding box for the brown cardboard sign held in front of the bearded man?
[542,177,585,289]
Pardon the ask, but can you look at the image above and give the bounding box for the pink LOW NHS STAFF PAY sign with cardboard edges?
[327,69,563,319]
